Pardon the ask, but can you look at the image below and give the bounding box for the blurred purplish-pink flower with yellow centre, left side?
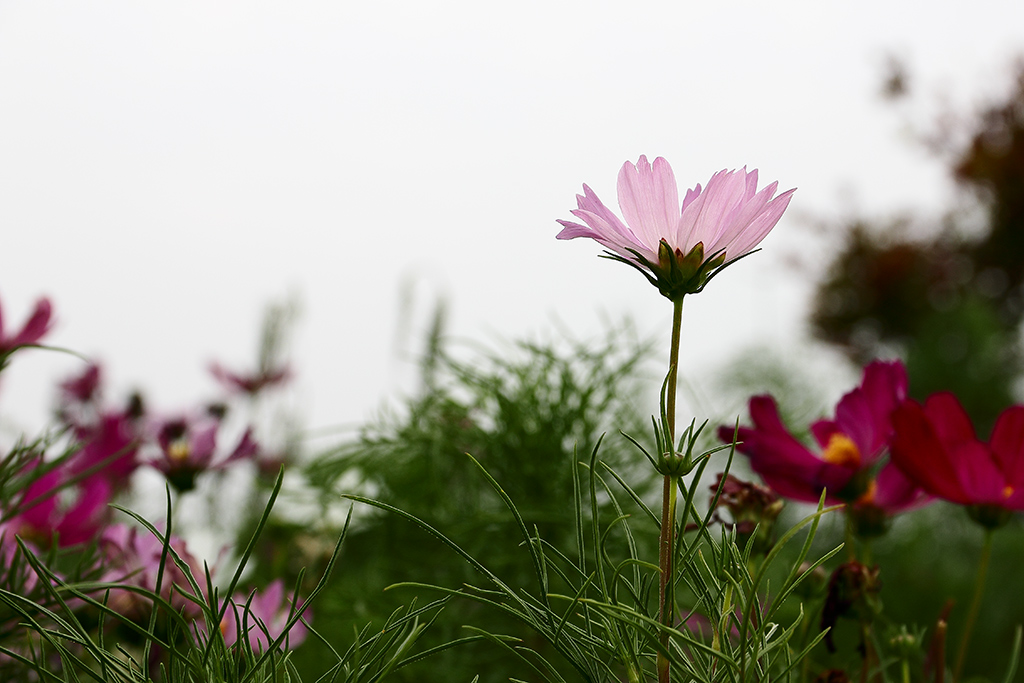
[148,418,259,493]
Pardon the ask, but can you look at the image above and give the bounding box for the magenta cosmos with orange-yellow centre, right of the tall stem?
[718,360,928,536]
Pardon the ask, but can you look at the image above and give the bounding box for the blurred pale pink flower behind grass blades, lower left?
[99,523,203,618]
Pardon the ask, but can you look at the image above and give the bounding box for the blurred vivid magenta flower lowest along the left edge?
[8,464,113,548]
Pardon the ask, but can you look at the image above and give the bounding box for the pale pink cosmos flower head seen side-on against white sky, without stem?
[557,157,796,301]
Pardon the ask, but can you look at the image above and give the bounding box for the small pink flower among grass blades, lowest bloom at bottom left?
[220,579,312,652]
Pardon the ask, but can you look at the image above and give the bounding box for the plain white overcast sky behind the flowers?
[0,0,1024,438]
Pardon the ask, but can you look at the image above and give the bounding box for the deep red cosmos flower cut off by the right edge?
[892,392,1024,528]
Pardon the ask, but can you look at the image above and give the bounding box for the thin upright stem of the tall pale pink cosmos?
[657,297,683,683]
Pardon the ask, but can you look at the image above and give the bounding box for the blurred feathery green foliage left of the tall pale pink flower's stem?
[286,326,656,681]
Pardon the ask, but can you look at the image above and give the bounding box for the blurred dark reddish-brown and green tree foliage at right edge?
[811,67,1024,431]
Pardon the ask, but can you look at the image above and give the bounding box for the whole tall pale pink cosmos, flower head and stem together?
[558,157,795,683]
